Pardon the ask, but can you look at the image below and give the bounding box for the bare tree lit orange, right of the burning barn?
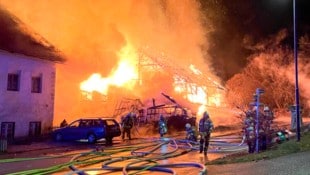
[226,47,294,108]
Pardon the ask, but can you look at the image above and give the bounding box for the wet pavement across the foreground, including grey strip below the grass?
[0,121,310,175]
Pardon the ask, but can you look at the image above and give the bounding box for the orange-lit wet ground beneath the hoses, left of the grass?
[0,133,246,174]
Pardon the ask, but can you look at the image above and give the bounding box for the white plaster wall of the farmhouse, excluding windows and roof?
[0,50,56,138]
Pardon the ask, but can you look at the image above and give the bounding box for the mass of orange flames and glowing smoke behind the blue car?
[1,0,229,125]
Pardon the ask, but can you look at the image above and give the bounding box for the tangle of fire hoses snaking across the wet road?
[0,138,244,175]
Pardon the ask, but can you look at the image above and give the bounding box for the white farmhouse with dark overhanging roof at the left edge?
[0,6,64,141]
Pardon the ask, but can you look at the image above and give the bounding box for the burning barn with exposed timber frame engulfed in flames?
[80,49,224,125]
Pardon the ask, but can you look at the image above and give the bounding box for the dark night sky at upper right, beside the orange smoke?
[201,0,310,80]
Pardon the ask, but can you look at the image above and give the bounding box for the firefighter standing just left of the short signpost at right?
[244,111,256,153]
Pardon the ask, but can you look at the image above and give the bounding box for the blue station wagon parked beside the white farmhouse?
[53,118,121,144]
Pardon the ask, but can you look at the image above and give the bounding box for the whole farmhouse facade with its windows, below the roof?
[0,50,56,141]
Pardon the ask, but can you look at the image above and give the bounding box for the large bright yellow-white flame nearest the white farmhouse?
[80,44,138,100]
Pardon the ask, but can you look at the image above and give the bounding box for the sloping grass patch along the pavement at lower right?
[206,132,310,165]
